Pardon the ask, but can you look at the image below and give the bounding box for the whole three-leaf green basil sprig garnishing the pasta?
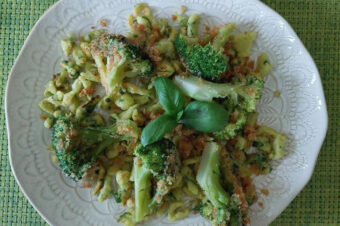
[141,77,229,146]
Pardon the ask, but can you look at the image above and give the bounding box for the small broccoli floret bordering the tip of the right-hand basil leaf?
[214,109,247,140]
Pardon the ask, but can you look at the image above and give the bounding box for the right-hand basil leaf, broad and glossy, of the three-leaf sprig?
[179,101,229,133]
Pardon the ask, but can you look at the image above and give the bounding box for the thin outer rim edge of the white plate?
[4,0,329,225]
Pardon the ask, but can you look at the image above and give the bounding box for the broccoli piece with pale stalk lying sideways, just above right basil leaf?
[175,76,264,112]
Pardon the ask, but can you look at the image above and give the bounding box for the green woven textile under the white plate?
[0,0,340,225]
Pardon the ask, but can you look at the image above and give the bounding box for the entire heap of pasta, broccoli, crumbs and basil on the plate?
[39,4,286,225]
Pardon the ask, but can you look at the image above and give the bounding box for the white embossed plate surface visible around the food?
[6,0,327,226]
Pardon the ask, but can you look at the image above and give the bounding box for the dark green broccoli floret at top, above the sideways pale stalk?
[175,34,228,80]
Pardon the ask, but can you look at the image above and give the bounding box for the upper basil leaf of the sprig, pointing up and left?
[154,77,185,116]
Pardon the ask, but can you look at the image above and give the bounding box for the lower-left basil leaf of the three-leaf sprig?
[141,114,177,146]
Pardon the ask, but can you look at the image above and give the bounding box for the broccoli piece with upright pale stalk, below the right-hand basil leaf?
[196,142,234,225]
